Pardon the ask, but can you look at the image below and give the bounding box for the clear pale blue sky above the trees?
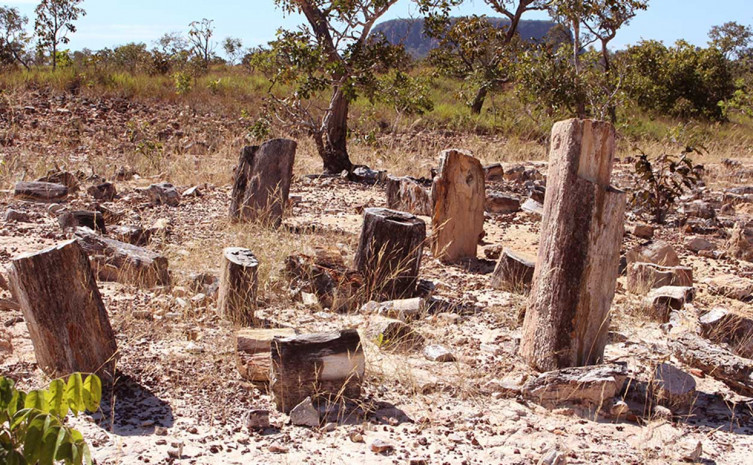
[5,0,753,54]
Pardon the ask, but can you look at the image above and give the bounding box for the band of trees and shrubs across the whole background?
[0,0,753,173]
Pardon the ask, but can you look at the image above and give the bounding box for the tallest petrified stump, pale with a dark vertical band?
[520,119,625,371]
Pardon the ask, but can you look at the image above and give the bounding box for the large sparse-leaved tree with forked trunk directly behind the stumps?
[256,0,451,173]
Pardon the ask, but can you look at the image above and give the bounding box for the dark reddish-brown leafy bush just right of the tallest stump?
[631,147,701,224]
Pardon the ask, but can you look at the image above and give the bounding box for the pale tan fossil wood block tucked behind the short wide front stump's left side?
[235,328,295,383]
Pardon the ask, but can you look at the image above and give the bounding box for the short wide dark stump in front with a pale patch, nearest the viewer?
[270,329,366,413]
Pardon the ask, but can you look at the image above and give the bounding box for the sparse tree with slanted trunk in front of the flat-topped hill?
[427,0,551,115]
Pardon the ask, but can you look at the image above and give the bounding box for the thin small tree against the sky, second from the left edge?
[34,0,86,70]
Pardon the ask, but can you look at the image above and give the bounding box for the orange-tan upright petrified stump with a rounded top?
[431,150,486,263]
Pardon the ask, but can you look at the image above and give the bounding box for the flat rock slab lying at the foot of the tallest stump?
[521,363,627,408]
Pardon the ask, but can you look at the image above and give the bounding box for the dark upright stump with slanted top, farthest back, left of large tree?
[230,139,298,225]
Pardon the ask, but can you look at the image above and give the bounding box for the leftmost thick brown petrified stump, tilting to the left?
[10,240,117,379]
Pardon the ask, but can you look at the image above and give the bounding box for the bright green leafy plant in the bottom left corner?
[0,373,102,465]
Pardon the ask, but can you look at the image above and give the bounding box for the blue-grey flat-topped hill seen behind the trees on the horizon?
[372,17,557,58]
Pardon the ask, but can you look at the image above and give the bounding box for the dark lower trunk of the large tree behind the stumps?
[319,87,353,174]
